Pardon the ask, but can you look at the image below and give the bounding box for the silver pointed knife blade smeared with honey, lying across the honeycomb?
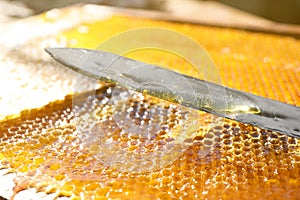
[45,48,300,138]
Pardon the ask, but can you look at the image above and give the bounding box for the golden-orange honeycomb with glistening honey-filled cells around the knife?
[0,13,300,199]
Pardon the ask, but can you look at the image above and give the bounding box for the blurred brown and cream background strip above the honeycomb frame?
[0,0,300,24]
